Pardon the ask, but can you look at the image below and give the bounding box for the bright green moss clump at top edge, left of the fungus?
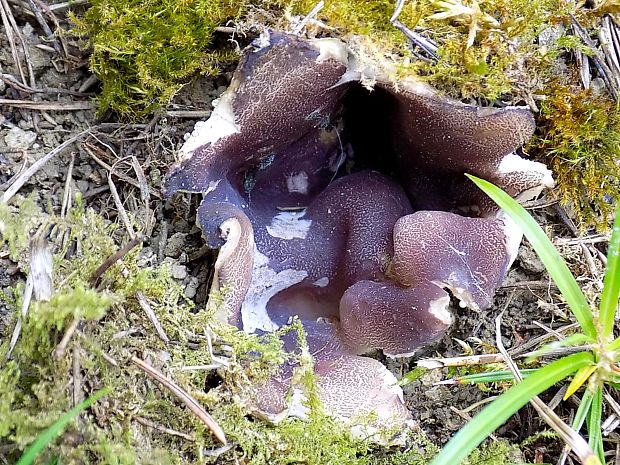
[73,0,243,117]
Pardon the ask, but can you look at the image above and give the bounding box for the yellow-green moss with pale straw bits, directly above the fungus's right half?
[408,0,569,101]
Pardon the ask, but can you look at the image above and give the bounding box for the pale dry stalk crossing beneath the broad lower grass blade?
[495,310,596,463]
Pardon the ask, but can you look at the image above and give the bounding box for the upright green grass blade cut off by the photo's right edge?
[599,206,620,340]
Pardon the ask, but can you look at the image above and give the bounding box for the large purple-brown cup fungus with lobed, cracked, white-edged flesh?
[166,32,553,434]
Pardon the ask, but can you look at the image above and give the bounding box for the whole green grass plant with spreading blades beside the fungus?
[431,175,620,465]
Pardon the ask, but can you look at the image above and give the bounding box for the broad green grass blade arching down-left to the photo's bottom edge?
[431,352,594,465]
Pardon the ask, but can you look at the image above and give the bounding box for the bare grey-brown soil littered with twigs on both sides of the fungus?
[0,0,605,463]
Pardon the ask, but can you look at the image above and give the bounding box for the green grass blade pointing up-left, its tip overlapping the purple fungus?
[466,174,596,337]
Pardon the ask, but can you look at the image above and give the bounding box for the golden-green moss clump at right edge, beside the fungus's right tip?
[532,85,620,227]
